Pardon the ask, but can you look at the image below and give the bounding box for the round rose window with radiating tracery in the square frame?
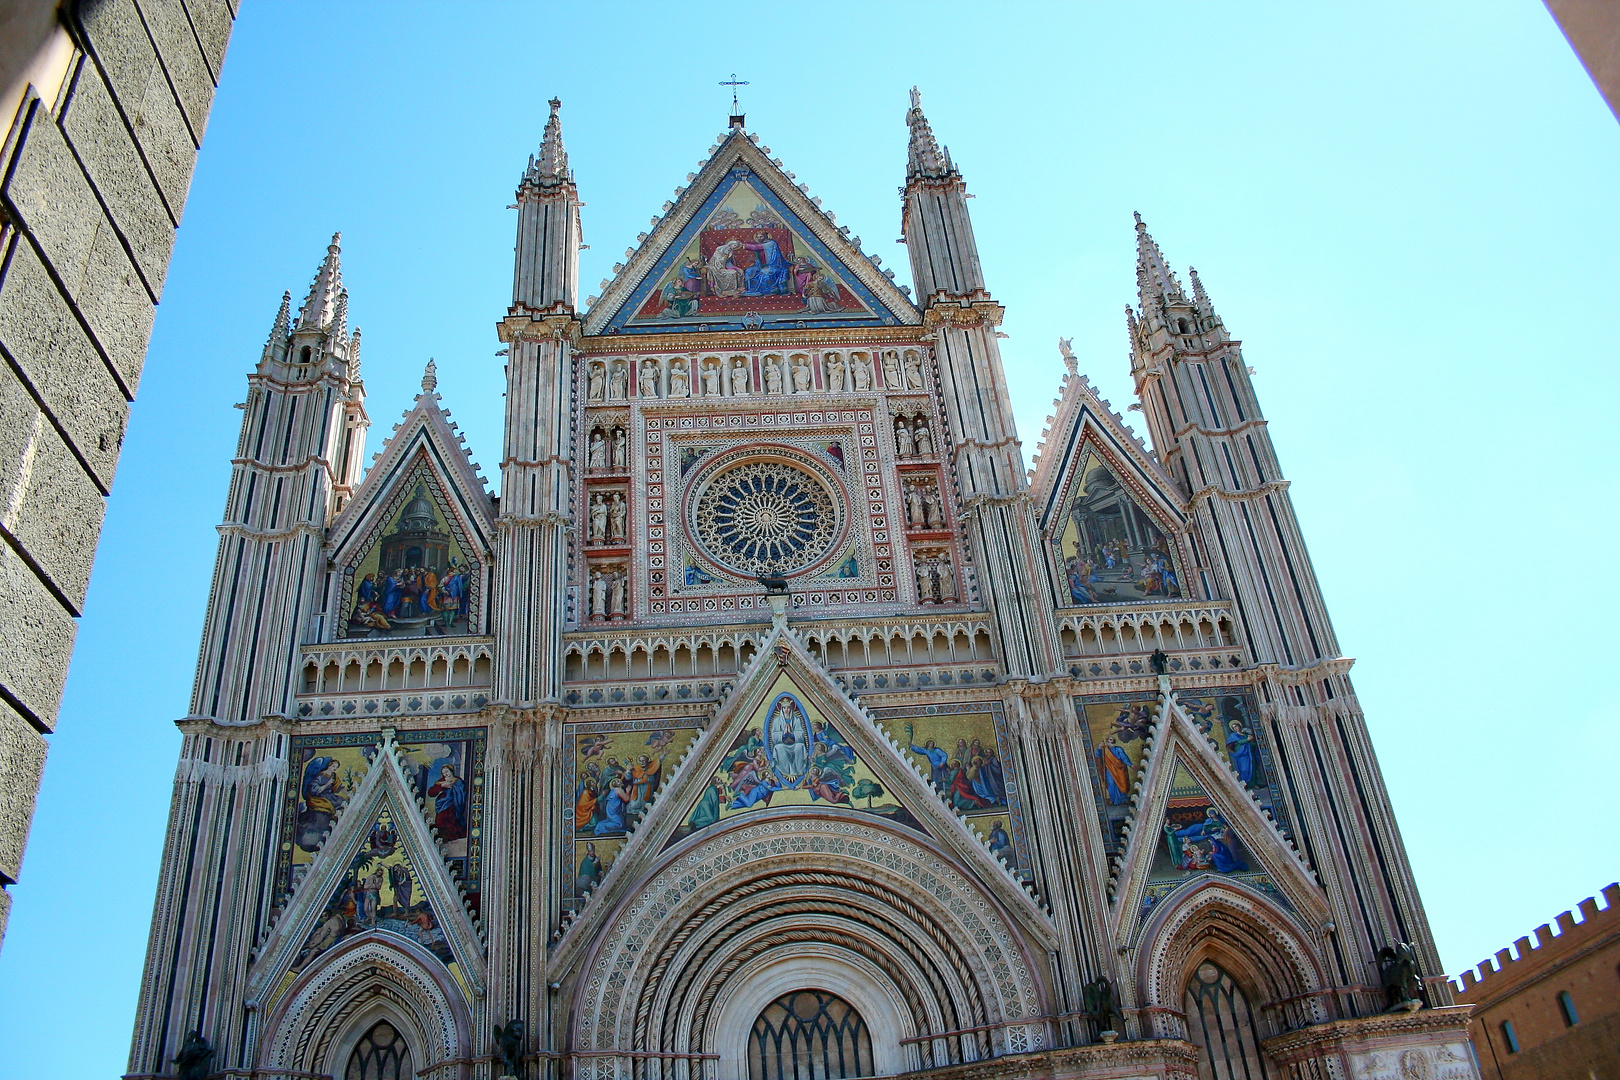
[689,460,839,576]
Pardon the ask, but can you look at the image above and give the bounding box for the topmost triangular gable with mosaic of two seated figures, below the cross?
[585,130,920,334]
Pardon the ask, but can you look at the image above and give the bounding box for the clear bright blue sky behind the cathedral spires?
[0,0,1620,1077]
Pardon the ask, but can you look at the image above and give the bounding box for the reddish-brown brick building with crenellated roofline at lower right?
[1456,884,1620,1080]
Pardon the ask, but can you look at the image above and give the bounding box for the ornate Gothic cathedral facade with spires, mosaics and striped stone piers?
[130,91,1477,1080]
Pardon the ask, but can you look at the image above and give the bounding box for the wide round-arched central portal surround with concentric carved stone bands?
[570,811,1047,1080]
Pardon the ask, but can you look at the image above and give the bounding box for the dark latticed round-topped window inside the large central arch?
[748,989,876,1080]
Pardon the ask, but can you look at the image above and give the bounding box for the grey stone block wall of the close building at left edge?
[0,0,240,933]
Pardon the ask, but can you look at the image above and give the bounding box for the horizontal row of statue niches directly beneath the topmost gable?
[585,348,927,405]
